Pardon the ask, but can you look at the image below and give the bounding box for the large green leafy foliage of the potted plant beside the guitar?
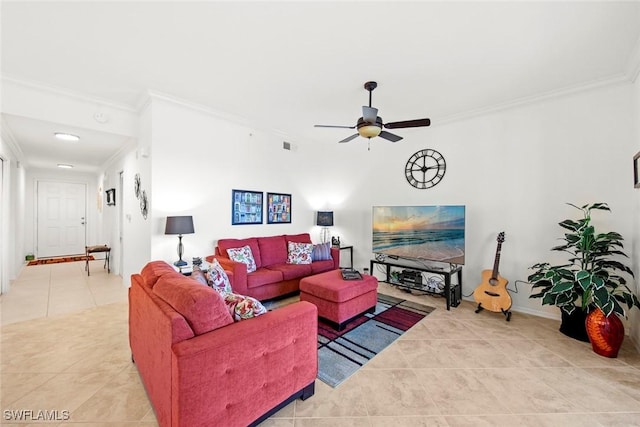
[528,203,640,317]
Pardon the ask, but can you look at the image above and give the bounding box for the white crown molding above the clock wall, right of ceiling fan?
[432,73,630,126]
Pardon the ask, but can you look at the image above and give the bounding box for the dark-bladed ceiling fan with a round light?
[315,82,431,142]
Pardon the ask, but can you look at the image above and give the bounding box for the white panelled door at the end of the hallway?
[37,181,87,258]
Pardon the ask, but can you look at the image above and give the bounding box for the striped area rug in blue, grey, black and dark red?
[318,294,435,387]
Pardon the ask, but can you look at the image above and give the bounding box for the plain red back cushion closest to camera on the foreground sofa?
[153,275,233,335]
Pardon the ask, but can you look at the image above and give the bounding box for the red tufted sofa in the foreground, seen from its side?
[129,261,318,427]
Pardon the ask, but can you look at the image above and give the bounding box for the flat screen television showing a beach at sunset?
[372,205,465,264]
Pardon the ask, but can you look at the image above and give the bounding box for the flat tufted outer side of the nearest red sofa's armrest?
[172,301,318,425]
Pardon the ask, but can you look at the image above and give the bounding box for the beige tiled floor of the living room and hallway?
[0,263,640,427]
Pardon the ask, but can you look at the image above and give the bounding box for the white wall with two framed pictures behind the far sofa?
[143,98,313,261]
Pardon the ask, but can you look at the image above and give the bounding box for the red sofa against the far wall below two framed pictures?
[206,233,340,301]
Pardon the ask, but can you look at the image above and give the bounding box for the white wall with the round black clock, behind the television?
[303,85,637,317]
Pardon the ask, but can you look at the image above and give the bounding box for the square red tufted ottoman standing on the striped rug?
[300,270,378,331]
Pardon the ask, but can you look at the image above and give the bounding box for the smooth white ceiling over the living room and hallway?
[1,1,640,172]
